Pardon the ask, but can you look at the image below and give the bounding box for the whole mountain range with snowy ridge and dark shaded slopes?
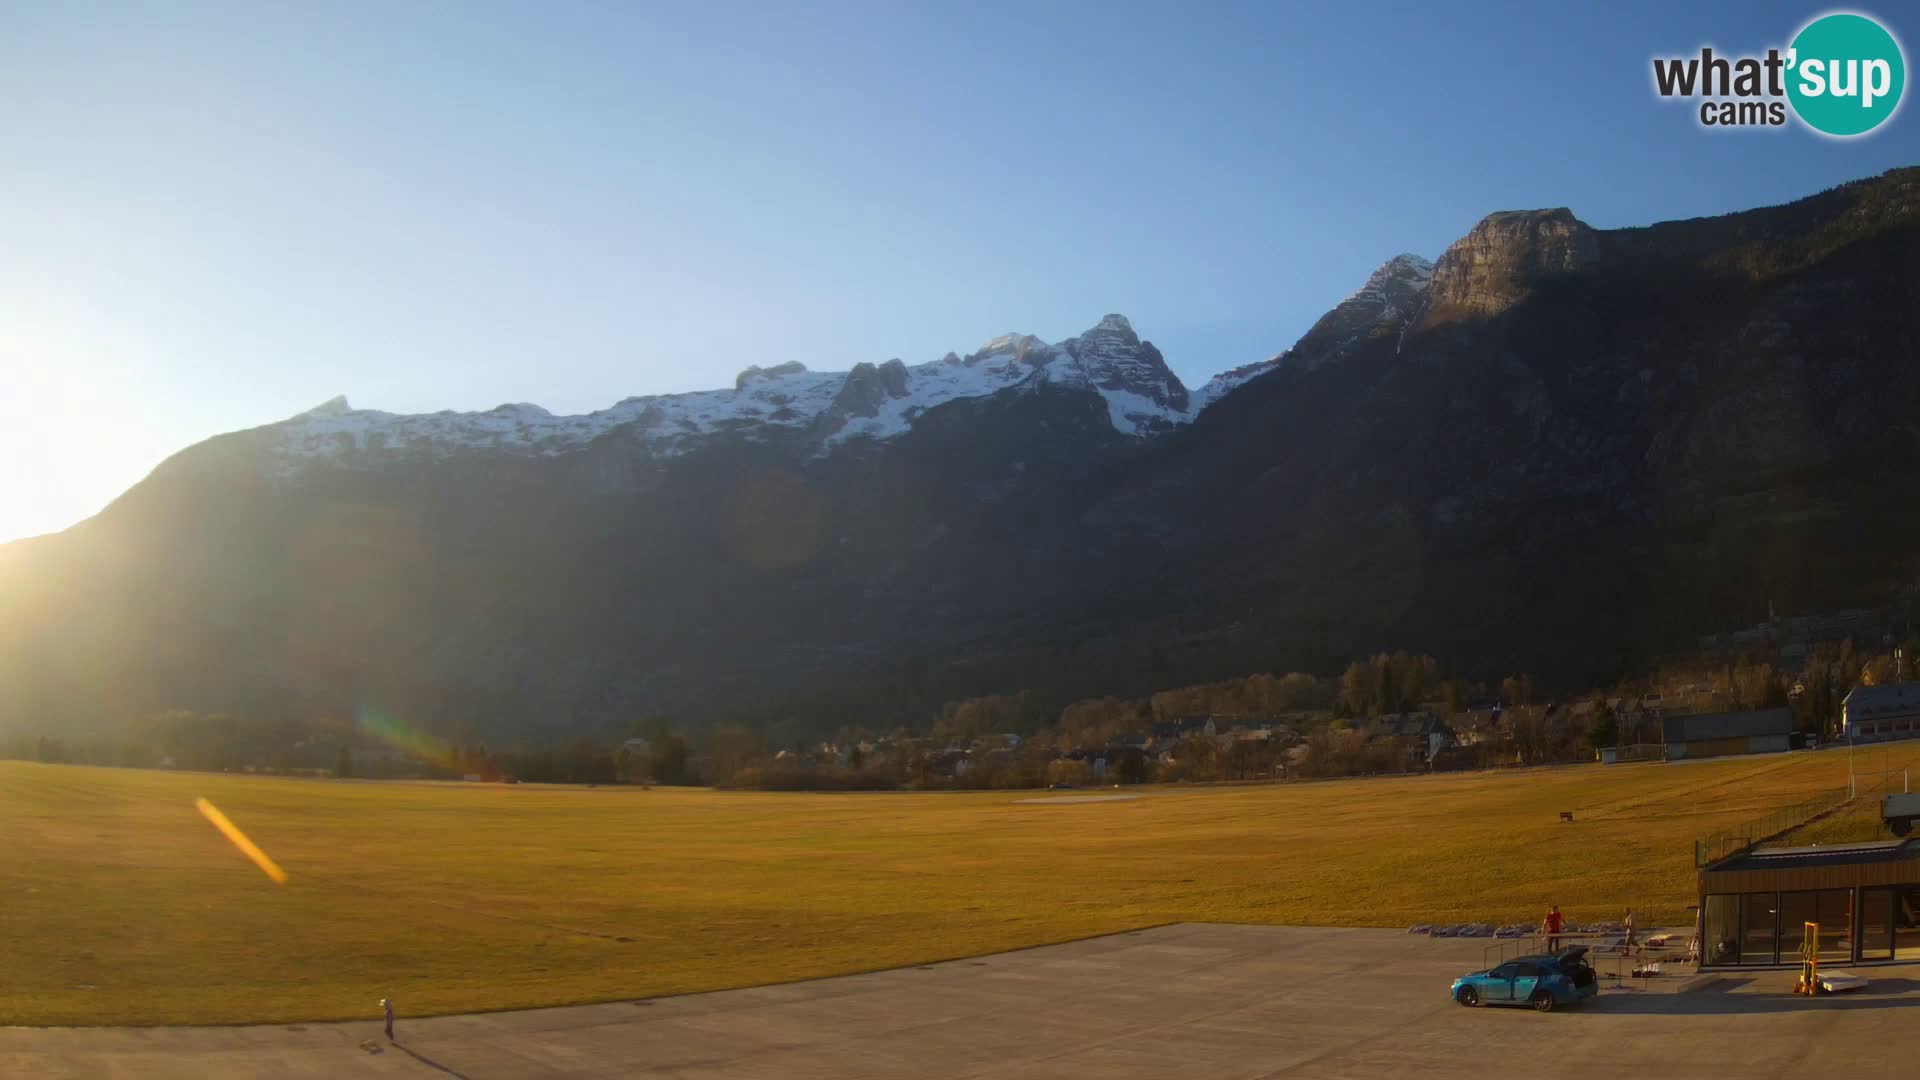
[0,169,1920,738]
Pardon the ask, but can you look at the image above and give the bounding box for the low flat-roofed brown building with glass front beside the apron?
[1699,838,1920,969]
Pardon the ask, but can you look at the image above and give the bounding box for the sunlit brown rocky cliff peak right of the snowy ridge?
[1427,208,1599,325]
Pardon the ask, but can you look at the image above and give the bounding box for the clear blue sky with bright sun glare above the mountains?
[0,0,1920,540]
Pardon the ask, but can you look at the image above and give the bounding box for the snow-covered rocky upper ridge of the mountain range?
[276,256,1432,469]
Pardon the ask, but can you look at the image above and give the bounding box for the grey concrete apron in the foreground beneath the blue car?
[0,924,1920,1080]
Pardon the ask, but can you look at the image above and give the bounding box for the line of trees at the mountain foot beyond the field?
[0,640,1889,790]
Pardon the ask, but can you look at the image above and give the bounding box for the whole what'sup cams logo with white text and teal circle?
[1653,12,1907,138]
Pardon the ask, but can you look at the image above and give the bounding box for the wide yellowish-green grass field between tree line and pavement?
[0,746,1920,1024]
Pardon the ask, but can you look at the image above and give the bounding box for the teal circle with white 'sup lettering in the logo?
[1788,13,1907,138]
